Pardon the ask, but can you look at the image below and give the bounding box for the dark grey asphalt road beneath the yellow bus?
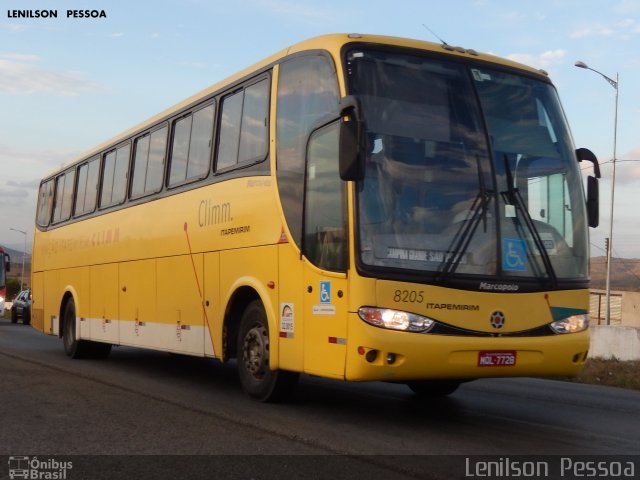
[0,320,640,479]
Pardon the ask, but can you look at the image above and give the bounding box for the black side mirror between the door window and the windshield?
[339,95,364,181]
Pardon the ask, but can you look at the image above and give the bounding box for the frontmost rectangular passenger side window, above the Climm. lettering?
[216,79,269,170]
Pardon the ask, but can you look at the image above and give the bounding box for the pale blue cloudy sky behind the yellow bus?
[0,0,640,258]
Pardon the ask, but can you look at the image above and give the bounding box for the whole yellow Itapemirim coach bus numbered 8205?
[32,34,599,401]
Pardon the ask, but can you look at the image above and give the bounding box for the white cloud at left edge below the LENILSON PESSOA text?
[0,53,105,97]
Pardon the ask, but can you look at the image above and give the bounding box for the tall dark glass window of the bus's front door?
[303,122,347,271]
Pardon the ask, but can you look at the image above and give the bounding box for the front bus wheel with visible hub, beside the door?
[237,300,299,402]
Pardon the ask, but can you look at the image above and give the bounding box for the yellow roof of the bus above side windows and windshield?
[44,33,547,179]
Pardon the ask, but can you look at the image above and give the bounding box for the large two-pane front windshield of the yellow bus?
[347,48,588,282]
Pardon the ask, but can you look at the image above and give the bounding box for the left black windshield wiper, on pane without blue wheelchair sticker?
[438,155,495,281]
